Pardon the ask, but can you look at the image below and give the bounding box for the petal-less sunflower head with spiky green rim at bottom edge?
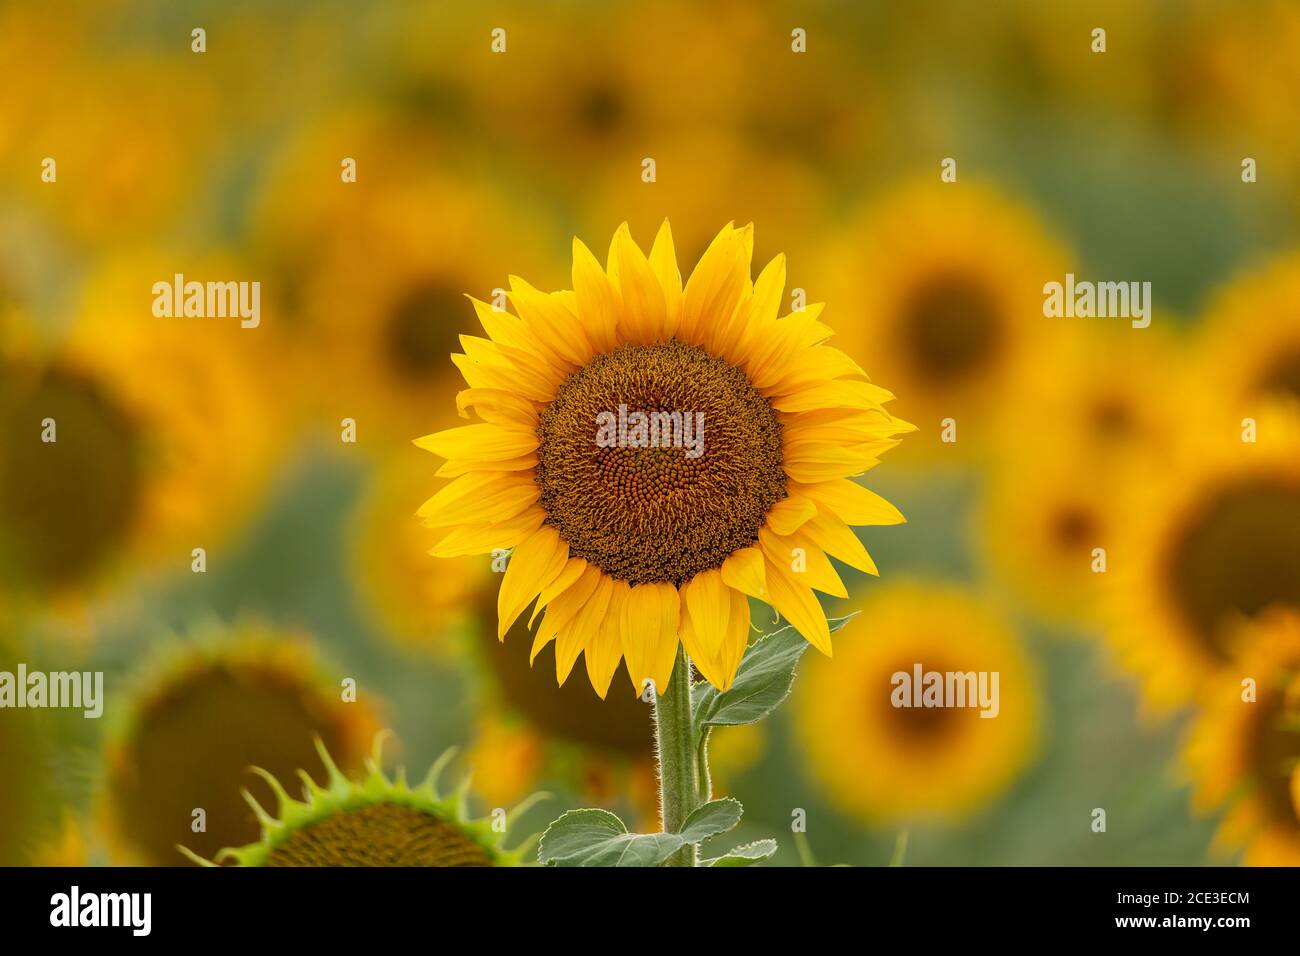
[179,734,540,866]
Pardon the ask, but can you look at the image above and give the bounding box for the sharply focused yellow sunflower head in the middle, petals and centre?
[416,222,911,697]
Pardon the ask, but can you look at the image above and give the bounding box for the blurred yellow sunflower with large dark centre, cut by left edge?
[0,256,277,613]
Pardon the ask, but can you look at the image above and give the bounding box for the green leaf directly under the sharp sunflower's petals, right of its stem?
[694,613,857,741]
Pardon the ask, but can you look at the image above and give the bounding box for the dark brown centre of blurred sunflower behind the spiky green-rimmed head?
[111,666,359,866]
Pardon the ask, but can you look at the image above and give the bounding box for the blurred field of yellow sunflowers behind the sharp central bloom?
[0,0,1300,865]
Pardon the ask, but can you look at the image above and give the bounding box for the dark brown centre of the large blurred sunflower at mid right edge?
[1167,477,1300,659]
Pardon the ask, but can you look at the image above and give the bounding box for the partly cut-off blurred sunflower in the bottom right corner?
[1183,611,1300,866]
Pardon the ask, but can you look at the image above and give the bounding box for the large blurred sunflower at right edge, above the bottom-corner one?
[1106,405,1300,711]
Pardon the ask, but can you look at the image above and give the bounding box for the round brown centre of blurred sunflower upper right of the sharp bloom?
[902,274,1002,385]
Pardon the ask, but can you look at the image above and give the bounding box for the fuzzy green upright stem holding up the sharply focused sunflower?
[654,646,705,866]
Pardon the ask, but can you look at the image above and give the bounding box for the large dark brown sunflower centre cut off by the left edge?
[0,368,142,588]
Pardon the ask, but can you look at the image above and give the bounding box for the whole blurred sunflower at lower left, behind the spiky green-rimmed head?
[101,624,378,866]
